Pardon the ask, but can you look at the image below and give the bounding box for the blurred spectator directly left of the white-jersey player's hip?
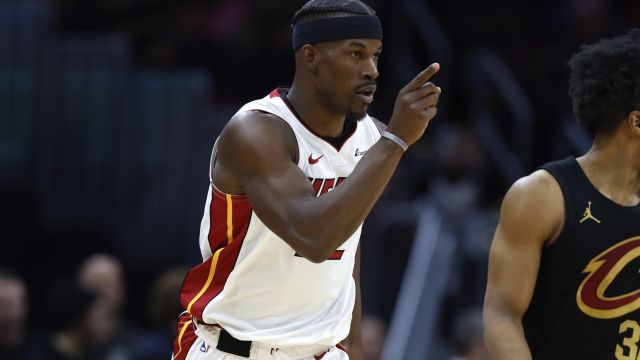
[131,268,189,360]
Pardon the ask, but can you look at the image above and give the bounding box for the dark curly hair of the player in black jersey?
[568,29,640,135]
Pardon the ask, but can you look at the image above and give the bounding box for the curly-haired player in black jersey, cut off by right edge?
[484,30,640,360]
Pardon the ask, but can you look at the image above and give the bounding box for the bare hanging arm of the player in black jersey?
[484,171,564,360]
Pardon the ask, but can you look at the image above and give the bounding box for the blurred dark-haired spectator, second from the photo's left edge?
[25,278,97,360]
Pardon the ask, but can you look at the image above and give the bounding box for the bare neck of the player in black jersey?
[578,135,640,206]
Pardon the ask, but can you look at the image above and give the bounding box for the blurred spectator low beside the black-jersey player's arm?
[451,308,491,360]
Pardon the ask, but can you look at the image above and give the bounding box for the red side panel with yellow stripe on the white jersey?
[180,186,252,322]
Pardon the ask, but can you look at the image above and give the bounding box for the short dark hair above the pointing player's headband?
[292,0,376,25]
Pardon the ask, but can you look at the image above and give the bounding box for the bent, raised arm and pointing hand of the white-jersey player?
[212,65,440,262]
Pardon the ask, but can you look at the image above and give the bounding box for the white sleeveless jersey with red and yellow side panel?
[180,89,380,345]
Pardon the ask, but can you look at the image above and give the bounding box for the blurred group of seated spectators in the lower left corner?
[0,253,187,360]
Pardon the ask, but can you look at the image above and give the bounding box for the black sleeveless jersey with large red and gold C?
[523,157,640,360]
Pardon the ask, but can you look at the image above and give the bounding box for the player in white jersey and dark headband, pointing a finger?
[174,0,440,360]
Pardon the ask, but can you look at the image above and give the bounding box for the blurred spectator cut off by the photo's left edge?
[0,269,28,360]
